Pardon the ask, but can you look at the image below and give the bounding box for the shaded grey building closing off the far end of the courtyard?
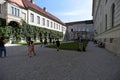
[65,20,94,40]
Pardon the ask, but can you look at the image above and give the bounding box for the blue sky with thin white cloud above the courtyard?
[34,0,92,22]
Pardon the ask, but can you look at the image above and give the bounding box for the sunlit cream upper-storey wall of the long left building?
[0,2,66,39]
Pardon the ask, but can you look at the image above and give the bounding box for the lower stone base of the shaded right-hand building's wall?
[95,25,120,55]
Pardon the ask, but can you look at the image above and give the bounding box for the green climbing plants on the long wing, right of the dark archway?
[21,20,63,38]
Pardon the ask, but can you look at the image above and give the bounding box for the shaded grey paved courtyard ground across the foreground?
[0,42,120,80]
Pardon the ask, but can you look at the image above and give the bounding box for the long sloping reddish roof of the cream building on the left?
[9,0,65,25]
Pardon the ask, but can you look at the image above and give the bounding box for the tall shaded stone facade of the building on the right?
[92,0,120,55]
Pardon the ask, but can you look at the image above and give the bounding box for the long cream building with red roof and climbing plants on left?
[0,0,66,41]
